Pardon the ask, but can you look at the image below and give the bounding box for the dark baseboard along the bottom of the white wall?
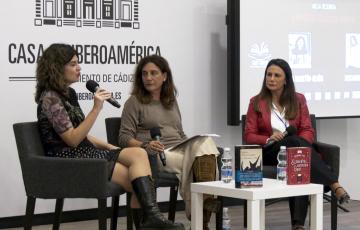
[0,198,243,229]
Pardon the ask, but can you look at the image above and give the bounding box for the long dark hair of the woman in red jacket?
[254,59,299,120]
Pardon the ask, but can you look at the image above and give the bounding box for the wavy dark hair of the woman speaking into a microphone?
[35,43,78,103]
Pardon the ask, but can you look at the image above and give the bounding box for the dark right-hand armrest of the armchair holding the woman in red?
[313,142,340,175]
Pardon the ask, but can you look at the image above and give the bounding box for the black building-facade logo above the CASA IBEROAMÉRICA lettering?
[34,0,140,29]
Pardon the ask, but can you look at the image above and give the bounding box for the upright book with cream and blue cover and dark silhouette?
[235,145,263,188]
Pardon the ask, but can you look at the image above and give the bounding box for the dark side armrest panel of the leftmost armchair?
[23,156,122,198]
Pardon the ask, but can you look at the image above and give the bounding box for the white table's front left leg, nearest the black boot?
[191,192,203,230]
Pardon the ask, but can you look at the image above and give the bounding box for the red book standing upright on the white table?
[286,147,311,184]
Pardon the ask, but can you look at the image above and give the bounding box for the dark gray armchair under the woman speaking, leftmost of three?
[13,122,125,230]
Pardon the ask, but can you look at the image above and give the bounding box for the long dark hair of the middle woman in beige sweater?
[131,55,177,109]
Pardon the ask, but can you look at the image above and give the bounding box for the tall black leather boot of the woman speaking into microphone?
[131,176,185,230]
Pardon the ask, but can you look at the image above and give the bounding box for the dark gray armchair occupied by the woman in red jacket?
[241,114,340,230]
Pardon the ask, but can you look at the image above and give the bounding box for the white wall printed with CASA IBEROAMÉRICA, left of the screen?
[0,0,233,217]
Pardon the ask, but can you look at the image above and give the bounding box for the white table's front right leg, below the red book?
[310,193,323,230]
